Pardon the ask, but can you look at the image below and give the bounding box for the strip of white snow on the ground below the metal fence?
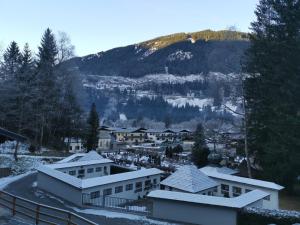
[68,206,177,225]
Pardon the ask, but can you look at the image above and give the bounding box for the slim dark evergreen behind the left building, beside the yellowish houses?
[86,103,99,151]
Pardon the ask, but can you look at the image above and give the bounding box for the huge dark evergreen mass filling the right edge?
[244,0,300,190]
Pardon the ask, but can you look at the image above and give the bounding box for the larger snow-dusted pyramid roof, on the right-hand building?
[161,165,219,193]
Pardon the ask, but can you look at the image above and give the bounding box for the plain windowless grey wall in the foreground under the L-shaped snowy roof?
[152,198,237,225]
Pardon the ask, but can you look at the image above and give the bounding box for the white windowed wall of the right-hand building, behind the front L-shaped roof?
[211,177,279,209]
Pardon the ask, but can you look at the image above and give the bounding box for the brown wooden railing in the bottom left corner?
[0,191,97,225]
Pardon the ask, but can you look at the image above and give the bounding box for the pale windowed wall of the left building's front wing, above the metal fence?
[83,175,160,199]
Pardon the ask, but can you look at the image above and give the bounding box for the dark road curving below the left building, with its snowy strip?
[0,173,183,225]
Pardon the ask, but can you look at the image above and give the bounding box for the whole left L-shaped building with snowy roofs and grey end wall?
[37,151,162,206]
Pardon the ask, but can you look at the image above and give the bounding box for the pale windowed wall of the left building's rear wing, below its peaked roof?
[58,163,111,179]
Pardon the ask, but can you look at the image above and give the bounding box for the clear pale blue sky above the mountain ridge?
[0,0,258,56]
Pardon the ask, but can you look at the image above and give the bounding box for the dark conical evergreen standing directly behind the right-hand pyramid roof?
[191,124,209,167]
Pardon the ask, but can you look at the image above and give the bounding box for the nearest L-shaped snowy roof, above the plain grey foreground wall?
[148,190,269,209]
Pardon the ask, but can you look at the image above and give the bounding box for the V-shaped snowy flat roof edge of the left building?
[38,166,163,189]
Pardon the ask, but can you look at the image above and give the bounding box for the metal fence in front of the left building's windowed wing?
[82,194,152,215]
